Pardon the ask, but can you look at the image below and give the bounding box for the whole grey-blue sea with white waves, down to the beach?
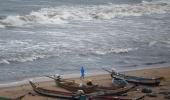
[0,0,170,84]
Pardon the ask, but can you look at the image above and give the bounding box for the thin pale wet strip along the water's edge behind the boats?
[0,64,169,89]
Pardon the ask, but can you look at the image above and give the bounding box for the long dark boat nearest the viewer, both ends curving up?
[30,81,135,100]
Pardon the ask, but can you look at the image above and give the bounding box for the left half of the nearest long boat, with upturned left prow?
[29,81,79,100]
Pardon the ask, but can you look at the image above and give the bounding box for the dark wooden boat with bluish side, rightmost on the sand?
[104,69,161,86]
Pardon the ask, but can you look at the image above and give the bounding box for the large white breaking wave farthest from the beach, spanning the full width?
[0,0,170,28]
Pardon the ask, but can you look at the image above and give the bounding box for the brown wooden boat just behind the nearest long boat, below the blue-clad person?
[46,76,98,93]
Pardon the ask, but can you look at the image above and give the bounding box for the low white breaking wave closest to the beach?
[0,48,137,64]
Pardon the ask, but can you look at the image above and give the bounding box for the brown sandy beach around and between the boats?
[0,67,170,100]
